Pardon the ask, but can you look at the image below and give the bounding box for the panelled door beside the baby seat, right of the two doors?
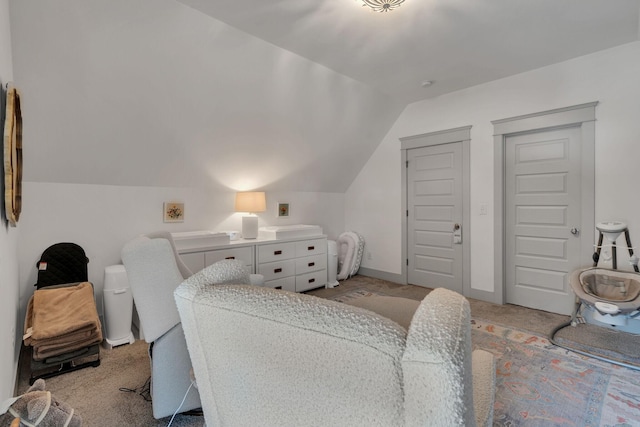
[504,127,582,314]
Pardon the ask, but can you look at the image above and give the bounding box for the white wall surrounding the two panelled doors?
[345,42,640,291]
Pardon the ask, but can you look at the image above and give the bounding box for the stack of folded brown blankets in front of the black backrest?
[24,282,102,360]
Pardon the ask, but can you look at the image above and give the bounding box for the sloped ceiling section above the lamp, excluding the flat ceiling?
[11,0,404,192]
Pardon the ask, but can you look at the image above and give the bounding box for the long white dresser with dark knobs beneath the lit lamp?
[178,235,327,292]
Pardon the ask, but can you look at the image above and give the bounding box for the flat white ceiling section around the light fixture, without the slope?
[178,0,640,102]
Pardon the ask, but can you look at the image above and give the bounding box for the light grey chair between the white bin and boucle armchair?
[121,232,264,419]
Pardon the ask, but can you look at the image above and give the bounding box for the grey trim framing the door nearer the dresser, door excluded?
[400,126,474,298]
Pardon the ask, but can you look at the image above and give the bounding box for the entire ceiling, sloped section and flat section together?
[10,0,640,192]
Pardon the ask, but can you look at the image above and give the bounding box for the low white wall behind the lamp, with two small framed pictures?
[19,182,344,322]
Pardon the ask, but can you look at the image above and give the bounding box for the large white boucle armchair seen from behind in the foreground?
[175,279,495,427]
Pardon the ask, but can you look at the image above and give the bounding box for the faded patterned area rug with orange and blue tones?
[471,319,640,427]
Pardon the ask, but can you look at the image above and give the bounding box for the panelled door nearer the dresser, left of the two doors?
[407,142,464,293]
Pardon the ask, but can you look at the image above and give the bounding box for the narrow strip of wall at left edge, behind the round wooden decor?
[0,0,22,401]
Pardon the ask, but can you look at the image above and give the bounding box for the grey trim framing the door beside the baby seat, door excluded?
[491,101,598,304]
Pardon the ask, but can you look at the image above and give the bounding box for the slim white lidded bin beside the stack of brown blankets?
[103,265,135,348]
